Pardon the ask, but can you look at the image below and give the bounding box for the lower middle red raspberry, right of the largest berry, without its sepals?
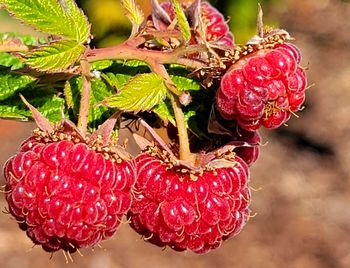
[128,148,250,253]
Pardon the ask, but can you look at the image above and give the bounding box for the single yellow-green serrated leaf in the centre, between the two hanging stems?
[103,73,167,112]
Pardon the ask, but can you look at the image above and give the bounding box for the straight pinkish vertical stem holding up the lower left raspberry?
[78,58,91,136]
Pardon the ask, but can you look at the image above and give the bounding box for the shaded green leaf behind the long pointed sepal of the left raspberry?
[0,88,64,122]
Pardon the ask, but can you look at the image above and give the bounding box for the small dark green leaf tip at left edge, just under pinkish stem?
[0,71,35,101]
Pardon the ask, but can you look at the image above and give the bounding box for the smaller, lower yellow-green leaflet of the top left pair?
[25,40,85,72]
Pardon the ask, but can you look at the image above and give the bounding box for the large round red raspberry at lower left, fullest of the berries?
[4,131,134,252]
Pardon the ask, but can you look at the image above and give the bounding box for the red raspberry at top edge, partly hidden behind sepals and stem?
[161,2,234,47]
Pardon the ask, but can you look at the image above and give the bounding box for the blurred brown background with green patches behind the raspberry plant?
[0,0,350,268]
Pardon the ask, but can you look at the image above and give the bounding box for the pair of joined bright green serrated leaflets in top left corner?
[0,0,90,72]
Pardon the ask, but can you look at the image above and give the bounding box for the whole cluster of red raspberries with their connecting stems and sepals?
[4,0,307,253]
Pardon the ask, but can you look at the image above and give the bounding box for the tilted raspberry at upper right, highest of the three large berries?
[216,40,307,131]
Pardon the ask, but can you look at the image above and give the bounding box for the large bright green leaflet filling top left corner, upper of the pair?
[0,0,90,43]
